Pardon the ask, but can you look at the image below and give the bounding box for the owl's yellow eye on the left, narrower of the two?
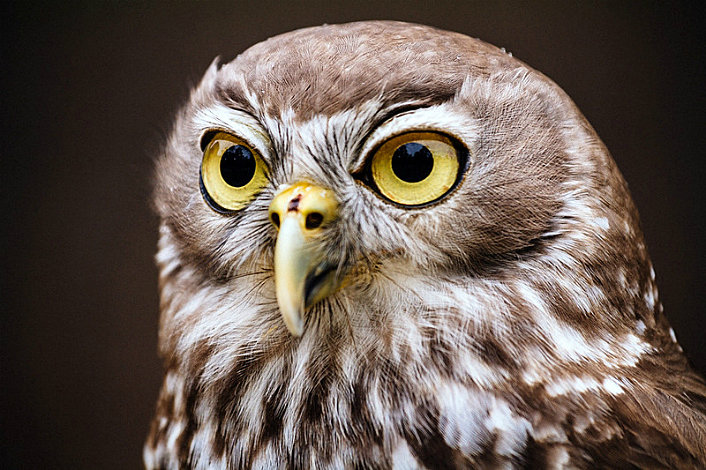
[201,132,267,212]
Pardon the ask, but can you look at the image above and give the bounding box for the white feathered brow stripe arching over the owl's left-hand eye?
[194,103,274,168]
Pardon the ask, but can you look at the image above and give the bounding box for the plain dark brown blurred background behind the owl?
[0,0,706,469]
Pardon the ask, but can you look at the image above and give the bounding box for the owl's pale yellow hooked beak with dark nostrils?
[269,183,340,336]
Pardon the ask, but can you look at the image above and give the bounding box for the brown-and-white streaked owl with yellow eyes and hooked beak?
[144,22,706,469]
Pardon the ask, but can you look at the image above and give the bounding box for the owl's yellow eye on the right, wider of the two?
[370,132,463,206]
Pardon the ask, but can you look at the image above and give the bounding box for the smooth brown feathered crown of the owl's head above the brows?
[215,22,519,120]
